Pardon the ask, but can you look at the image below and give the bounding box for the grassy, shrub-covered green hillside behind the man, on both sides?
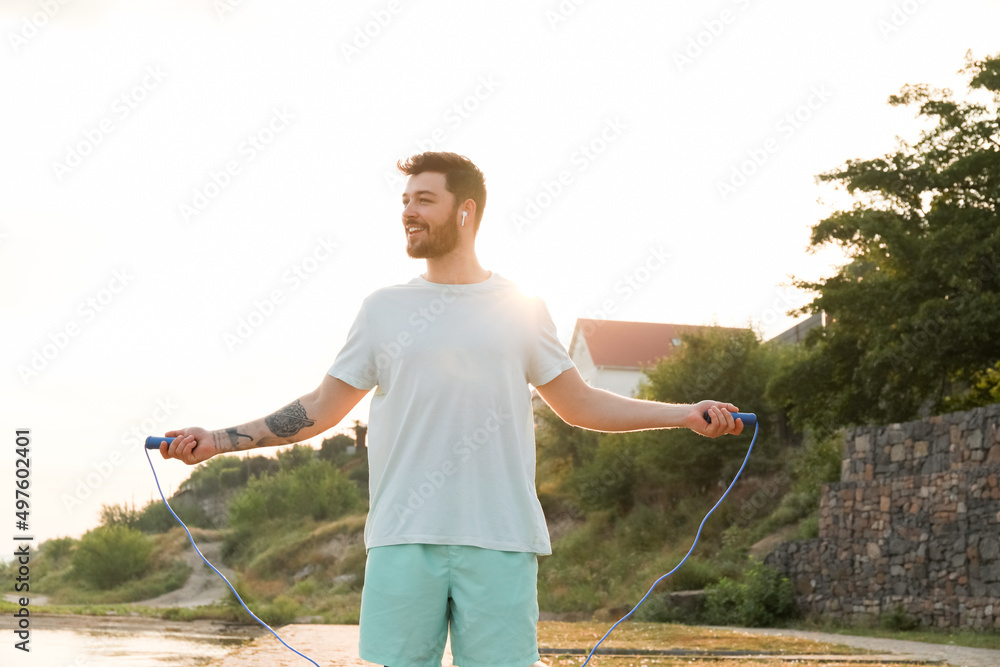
[5,331,852,622]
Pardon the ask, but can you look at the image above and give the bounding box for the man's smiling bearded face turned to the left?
[403,171,461,259]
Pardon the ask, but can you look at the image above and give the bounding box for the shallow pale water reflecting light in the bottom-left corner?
[0,621,249,667]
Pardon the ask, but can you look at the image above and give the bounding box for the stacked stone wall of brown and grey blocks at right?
[767,405,1000,629]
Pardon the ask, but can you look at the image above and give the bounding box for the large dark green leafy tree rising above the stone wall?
[771,54,1000,431]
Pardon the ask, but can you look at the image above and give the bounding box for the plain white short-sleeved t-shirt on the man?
[328,273,573,554]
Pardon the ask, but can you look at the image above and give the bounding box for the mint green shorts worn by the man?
[360,544,539,667]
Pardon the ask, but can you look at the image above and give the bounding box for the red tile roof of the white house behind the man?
[569,318,742,368]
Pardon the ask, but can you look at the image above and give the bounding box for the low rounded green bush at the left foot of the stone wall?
[705,561,796,627]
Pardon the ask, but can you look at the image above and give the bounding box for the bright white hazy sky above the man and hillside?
[0,0,1000,544]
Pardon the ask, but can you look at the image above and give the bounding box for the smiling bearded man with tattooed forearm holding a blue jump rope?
[160,153,743,667]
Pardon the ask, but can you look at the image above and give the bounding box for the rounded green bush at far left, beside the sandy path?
[73,525,153,590]
